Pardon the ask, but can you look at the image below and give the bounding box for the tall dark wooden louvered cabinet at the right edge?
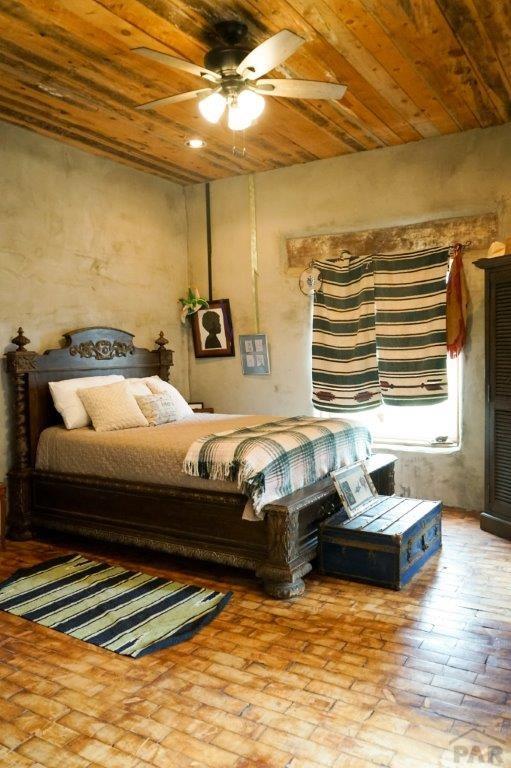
[475,255,511,539]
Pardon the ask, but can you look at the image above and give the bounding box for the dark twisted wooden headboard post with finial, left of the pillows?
[7,328,37,541]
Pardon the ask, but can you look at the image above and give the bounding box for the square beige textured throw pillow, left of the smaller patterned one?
[78,381,149,432]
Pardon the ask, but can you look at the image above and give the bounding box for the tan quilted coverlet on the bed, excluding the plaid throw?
[36,413,270,493]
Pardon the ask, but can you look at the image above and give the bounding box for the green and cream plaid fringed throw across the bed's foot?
[183,416,371,518]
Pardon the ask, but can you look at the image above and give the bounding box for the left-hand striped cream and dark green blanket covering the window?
[312,256,382,413]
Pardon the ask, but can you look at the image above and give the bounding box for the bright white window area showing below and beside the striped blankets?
[317,357,462,448]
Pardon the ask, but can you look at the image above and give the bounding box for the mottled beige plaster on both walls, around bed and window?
[0,123,511,509]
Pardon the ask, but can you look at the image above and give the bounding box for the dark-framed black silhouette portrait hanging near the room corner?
[192,299,235,357]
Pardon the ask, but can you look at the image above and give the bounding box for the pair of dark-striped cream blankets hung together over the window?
[312,246,449,413]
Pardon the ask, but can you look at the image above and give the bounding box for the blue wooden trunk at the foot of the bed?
[319,496,442,589]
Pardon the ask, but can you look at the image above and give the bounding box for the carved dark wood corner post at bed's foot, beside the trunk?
[256,506,312,600]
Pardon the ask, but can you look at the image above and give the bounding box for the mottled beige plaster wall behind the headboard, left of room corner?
[0,123,188,481]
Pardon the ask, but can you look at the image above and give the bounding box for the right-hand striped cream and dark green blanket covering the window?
[374,246,449,405]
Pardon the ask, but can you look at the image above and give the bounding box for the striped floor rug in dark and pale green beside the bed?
[0,554,232,658]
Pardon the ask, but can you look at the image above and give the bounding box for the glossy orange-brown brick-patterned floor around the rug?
[0,511,511,768]
